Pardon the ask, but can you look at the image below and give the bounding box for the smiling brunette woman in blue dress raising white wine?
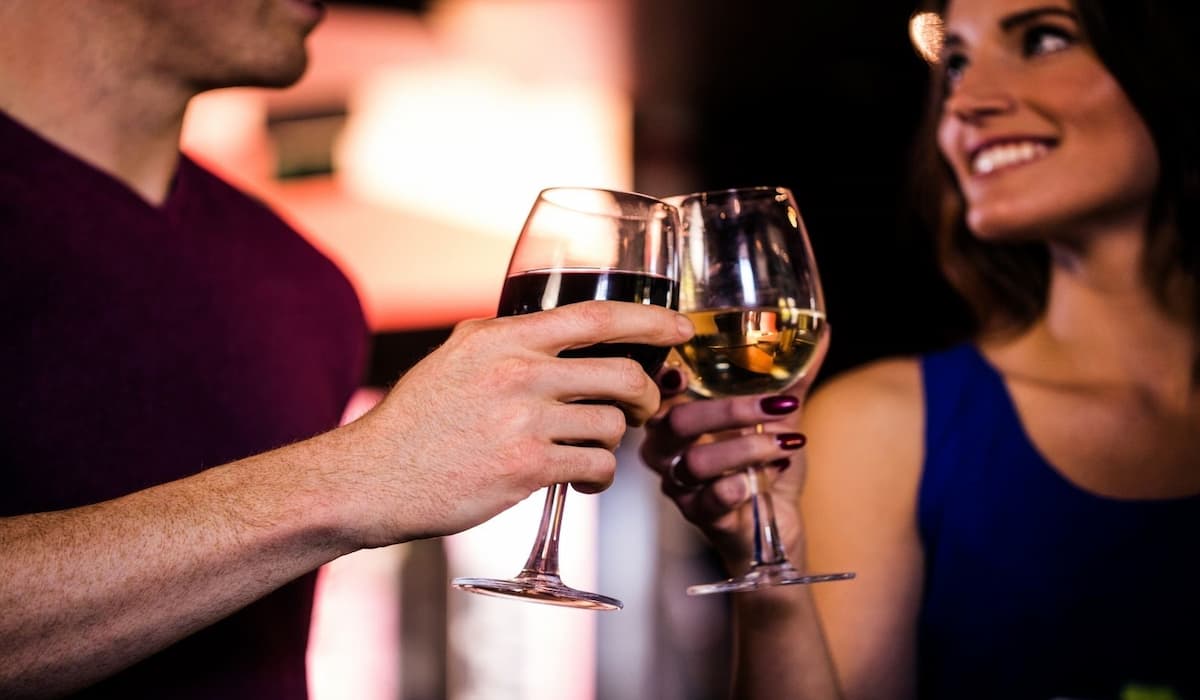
[642,0,1200,699]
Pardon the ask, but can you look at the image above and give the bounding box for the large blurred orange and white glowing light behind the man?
[185,0,632,331]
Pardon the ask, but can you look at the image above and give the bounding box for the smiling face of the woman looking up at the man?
[937,0,1158,240]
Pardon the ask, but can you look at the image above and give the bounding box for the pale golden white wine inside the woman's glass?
[676,306,826,397]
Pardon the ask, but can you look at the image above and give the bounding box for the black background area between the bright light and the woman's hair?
[635,0,966,378]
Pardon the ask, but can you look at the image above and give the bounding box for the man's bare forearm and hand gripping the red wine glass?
[0,301,691,696]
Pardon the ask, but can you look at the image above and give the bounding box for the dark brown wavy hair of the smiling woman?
[913,0,1200,333]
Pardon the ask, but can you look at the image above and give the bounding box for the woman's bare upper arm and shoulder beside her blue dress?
[800,357,924,696]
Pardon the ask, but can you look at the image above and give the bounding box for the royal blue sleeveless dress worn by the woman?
[917,345,1200,700]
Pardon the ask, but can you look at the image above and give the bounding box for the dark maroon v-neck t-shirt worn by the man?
[0,108,368,700]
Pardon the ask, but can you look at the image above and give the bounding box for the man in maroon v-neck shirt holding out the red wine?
[0,0,691,699]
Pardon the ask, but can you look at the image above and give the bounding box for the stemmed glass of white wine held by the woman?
[665,187,854,596]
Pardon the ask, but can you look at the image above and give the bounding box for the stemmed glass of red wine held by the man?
[451,187,679,610]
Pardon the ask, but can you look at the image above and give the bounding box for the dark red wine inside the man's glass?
[496,270,679,376]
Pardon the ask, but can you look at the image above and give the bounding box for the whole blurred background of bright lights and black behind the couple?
[175,0,964,700]
